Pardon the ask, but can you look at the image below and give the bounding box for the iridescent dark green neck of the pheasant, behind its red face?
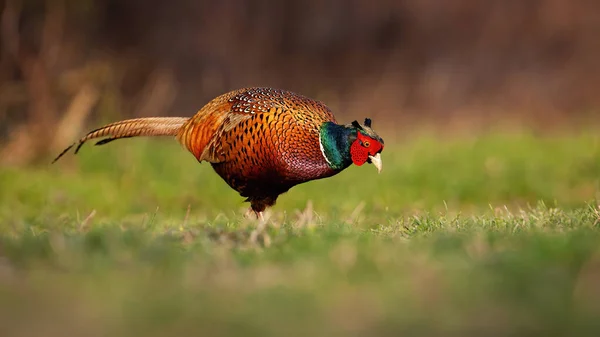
[319,122,356,170]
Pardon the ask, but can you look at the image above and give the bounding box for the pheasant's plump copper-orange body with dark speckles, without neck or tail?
[177,88,337,212]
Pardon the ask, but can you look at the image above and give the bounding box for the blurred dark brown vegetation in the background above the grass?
[0,0,600,164]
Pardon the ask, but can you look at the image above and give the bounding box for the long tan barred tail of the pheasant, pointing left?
[52,117,189,163]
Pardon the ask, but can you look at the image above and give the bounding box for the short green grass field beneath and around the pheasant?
[0,133,600,336]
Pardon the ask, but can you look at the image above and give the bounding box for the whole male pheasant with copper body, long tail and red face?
[53,88,384,219]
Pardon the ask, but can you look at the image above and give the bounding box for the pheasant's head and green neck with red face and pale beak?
[320,118,383,172]
